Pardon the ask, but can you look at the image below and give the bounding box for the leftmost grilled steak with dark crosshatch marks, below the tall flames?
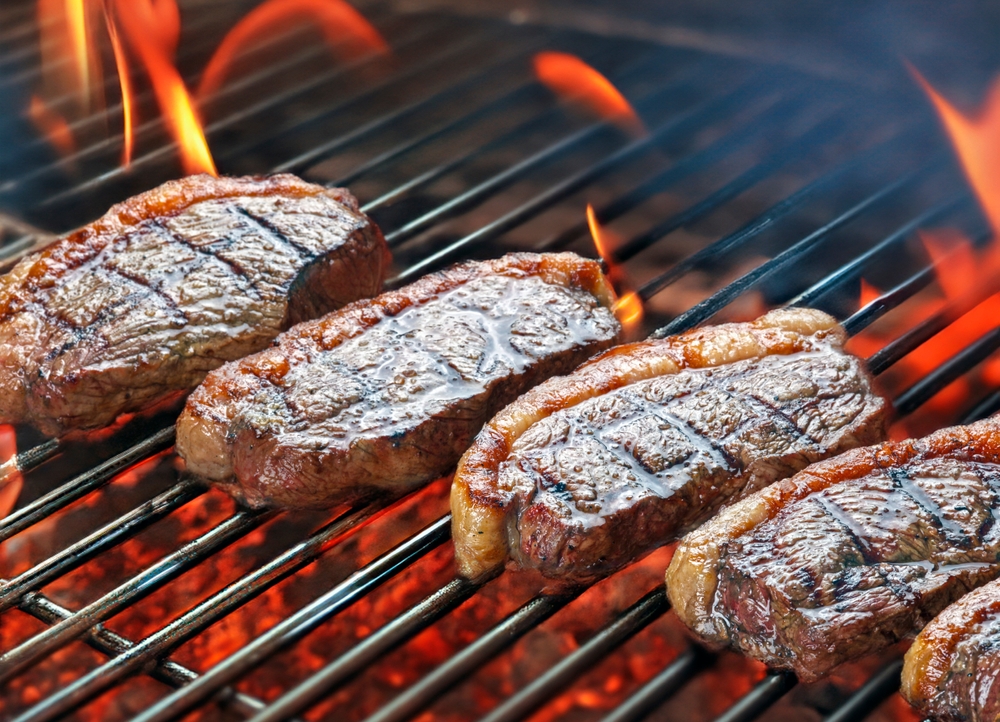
[0,175,390,434]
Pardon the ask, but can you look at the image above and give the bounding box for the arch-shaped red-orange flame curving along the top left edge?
[198,0,389,98]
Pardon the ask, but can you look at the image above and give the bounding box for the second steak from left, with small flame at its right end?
[177,253,620,508]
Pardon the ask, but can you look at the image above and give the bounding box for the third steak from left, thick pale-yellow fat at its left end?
[451,309,885,582]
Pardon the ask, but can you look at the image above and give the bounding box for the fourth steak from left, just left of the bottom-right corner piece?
[666,419,1000,681]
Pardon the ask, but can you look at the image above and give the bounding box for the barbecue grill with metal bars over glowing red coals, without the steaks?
[0,2,1000,722]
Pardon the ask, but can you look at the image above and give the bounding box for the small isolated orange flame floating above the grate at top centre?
[534,50,646,134]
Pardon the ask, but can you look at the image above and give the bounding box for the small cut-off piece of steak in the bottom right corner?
[901,581,1000,722]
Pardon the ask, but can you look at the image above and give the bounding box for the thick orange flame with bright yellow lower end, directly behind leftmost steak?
[108,0,217,175]
